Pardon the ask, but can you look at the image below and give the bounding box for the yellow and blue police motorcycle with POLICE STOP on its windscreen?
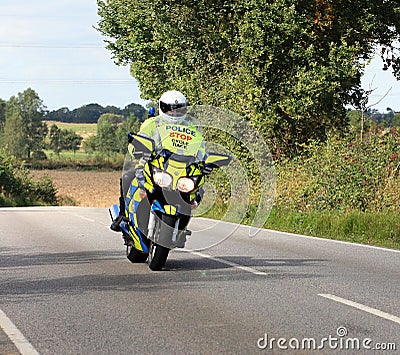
[109,124,231,271]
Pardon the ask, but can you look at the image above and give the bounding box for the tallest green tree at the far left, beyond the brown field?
[3,89,47,160]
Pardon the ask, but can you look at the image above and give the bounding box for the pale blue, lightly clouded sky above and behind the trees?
[0,0,400,112]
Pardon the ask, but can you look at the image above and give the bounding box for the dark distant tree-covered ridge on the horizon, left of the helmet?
[43,103,147,123]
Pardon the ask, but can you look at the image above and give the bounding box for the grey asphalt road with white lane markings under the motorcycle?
[0,207,400,354]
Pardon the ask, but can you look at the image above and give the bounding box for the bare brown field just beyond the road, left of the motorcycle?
[31,170,121,207]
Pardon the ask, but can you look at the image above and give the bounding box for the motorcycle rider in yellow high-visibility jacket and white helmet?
[110,90,205,231]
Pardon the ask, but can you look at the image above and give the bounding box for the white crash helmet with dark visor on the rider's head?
[159,90,187,124]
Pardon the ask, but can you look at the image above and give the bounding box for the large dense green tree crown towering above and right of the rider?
[98,0,400,154]
